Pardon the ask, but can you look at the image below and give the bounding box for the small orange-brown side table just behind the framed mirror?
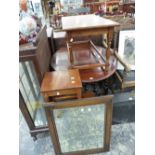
[41,69,82,102]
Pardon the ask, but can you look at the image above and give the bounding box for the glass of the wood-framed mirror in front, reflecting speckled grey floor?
[54,104,105,152]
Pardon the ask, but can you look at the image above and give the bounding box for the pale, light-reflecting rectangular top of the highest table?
[62,14,120,31]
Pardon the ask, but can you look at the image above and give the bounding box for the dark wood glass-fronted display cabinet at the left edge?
[19,26,52,139]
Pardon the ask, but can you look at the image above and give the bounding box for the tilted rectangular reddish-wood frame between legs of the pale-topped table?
[67,40,105,69]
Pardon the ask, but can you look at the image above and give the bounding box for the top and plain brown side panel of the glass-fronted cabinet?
[19,26,51,83]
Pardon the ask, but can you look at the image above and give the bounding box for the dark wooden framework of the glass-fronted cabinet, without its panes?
[19,26,51,137]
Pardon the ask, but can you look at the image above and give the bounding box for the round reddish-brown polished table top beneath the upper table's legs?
[51,46,117,83]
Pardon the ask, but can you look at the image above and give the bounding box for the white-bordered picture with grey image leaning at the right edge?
[117,30,135,70]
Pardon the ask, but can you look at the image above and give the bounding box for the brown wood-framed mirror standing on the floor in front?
[44,95,113,155]
